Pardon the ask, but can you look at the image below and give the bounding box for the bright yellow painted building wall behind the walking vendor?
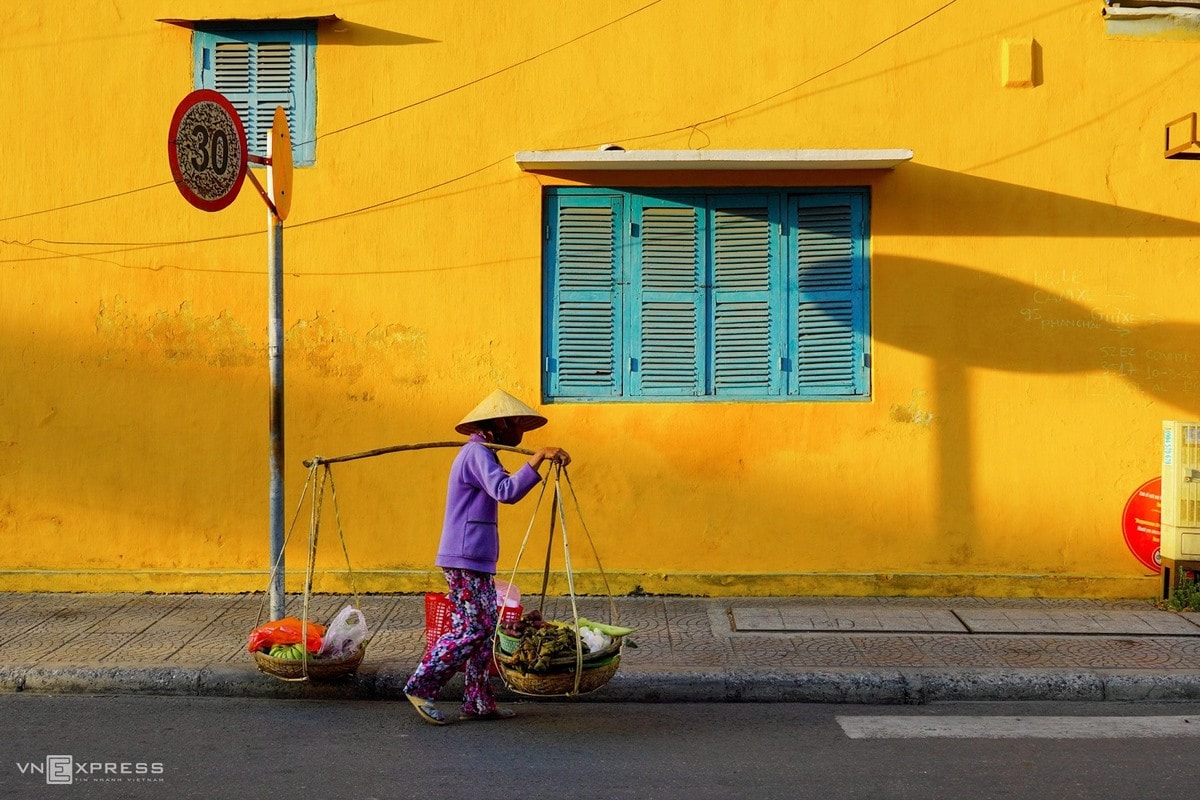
[0,0,1200,596]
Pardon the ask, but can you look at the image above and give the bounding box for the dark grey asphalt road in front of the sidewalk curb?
[0,693,1200,800]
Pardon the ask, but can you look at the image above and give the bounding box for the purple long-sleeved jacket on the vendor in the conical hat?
[436,434,541,575]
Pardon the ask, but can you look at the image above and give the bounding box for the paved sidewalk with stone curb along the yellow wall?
[0,594,1200,703]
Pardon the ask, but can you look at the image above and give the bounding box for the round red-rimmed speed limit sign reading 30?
[167,89,247,211]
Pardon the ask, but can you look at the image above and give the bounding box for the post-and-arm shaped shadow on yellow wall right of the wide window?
[872,255,1200,566]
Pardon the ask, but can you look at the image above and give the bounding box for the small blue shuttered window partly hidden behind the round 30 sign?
[193,29,317,167]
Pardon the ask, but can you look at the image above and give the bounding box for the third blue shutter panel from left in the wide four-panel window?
[709,194,784,397]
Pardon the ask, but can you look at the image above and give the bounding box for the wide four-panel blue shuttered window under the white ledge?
[544,187,870,401]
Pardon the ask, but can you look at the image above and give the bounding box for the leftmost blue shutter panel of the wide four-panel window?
[545,194,624,398]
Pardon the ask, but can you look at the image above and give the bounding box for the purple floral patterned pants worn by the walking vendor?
[404,570,499,714]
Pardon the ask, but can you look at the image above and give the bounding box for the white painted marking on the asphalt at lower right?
[838,716,1200,739]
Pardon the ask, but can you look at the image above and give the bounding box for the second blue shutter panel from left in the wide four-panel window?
[626,197,707,397]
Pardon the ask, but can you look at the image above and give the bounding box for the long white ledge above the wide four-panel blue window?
[514,150,912,173]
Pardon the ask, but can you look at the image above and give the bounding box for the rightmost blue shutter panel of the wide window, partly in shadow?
[788,194,868,396]
